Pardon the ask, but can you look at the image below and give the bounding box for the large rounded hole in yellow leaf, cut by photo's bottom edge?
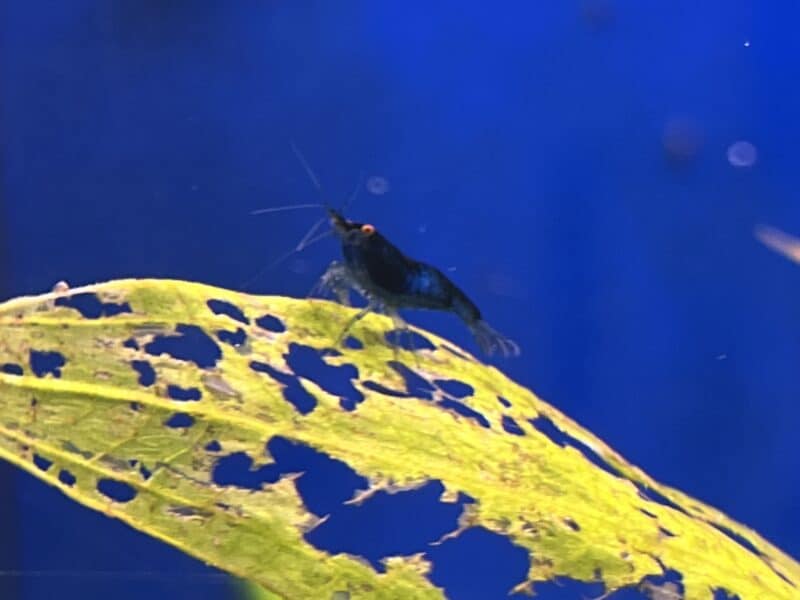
[425,527,532,600]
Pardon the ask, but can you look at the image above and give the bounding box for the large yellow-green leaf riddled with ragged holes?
[0,280,800,600]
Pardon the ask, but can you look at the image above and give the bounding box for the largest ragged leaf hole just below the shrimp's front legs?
[284,343,364,410]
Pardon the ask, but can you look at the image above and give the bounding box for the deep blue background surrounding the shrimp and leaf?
[0,0,800,600]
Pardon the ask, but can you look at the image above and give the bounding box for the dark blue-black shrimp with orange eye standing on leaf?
[319,206,520,356]
